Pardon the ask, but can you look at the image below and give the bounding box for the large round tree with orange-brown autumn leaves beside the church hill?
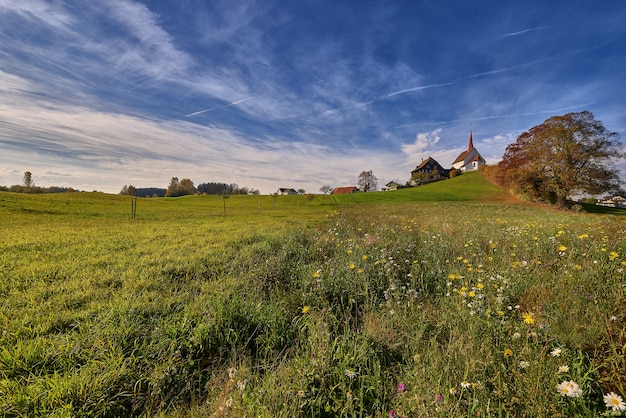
[498,111,623,206]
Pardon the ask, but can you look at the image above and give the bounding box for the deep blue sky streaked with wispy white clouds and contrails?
[0,0,626,193]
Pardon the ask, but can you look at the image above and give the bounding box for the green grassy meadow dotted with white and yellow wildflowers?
[0,174,626,417]
